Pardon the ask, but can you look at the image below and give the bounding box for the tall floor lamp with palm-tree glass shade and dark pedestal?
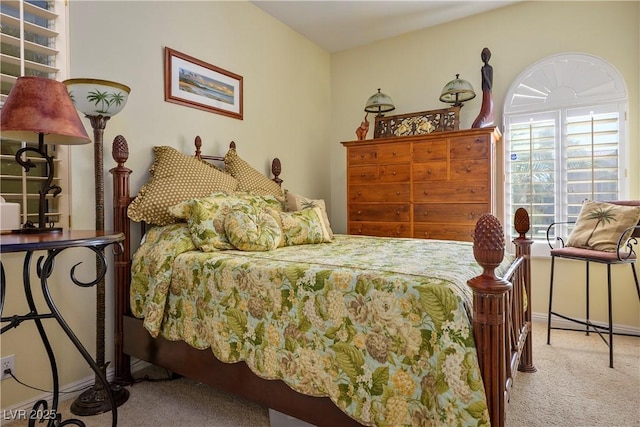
[63,79,131,416]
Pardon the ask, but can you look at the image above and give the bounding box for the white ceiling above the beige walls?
[252,0,519,53]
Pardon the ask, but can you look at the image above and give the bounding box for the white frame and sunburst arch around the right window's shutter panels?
[503,53,630,256]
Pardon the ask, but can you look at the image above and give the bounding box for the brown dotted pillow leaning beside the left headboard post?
[127,146,238,225]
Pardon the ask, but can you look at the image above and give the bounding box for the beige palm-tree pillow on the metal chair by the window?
[567,200,640,252]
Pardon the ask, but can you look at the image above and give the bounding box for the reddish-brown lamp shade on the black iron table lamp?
[0,77,91,145]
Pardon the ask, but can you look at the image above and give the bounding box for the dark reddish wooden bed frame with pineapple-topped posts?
[110,136,536,426]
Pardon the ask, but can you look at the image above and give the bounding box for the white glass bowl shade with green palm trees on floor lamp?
[63,79,131,117]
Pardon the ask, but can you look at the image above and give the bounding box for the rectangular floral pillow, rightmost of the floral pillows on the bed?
[279,207,332,246]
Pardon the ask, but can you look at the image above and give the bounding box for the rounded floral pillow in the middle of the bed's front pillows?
[224,205,282,251]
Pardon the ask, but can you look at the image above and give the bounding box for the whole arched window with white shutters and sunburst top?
[504,53,628,254]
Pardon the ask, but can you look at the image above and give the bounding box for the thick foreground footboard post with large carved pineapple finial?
[467,214,511,426]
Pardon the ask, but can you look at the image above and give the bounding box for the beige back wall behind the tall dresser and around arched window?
[330,1,640,328]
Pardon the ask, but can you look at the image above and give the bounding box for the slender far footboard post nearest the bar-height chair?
[513,208,537,372]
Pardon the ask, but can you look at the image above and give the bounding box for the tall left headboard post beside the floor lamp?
[109,135,133,384]
